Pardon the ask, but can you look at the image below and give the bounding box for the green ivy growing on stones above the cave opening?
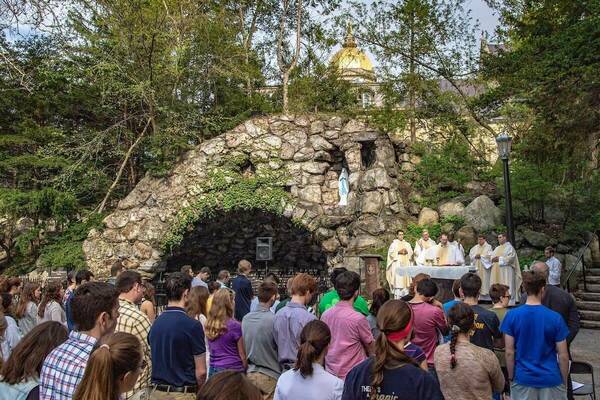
[161,159,292,251]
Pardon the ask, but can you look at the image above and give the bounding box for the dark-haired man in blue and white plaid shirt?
[40,282,119,400]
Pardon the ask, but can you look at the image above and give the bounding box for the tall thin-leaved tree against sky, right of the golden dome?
[353,0,495,147]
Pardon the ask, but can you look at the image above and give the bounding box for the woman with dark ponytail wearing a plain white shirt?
[274,320,344,400]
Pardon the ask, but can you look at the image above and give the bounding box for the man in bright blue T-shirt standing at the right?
[501,271,569,400]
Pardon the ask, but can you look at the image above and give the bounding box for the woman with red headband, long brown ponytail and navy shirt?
[342,300,442,400]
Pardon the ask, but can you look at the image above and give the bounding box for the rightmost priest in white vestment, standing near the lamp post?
[490,233,523,305]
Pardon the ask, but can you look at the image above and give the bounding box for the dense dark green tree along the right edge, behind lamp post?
[478,0,600,230]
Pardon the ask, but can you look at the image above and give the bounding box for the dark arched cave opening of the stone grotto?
[166,210,327,288]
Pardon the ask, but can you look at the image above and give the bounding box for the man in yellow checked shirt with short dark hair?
[115,271,152,400]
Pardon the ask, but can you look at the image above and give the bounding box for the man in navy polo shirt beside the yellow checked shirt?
[148,272,206,400]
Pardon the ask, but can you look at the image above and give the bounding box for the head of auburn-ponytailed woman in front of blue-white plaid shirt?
[73,332,144,400]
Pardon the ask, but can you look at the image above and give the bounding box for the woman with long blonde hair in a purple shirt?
[206,289,248,377]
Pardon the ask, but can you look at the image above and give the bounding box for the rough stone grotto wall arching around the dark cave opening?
[83,115,409,276]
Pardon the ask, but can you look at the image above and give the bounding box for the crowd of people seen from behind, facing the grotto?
[0,260,579,400]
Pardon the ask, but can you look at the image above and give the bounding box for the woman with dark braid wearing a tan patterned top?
[434,303,504,400]
